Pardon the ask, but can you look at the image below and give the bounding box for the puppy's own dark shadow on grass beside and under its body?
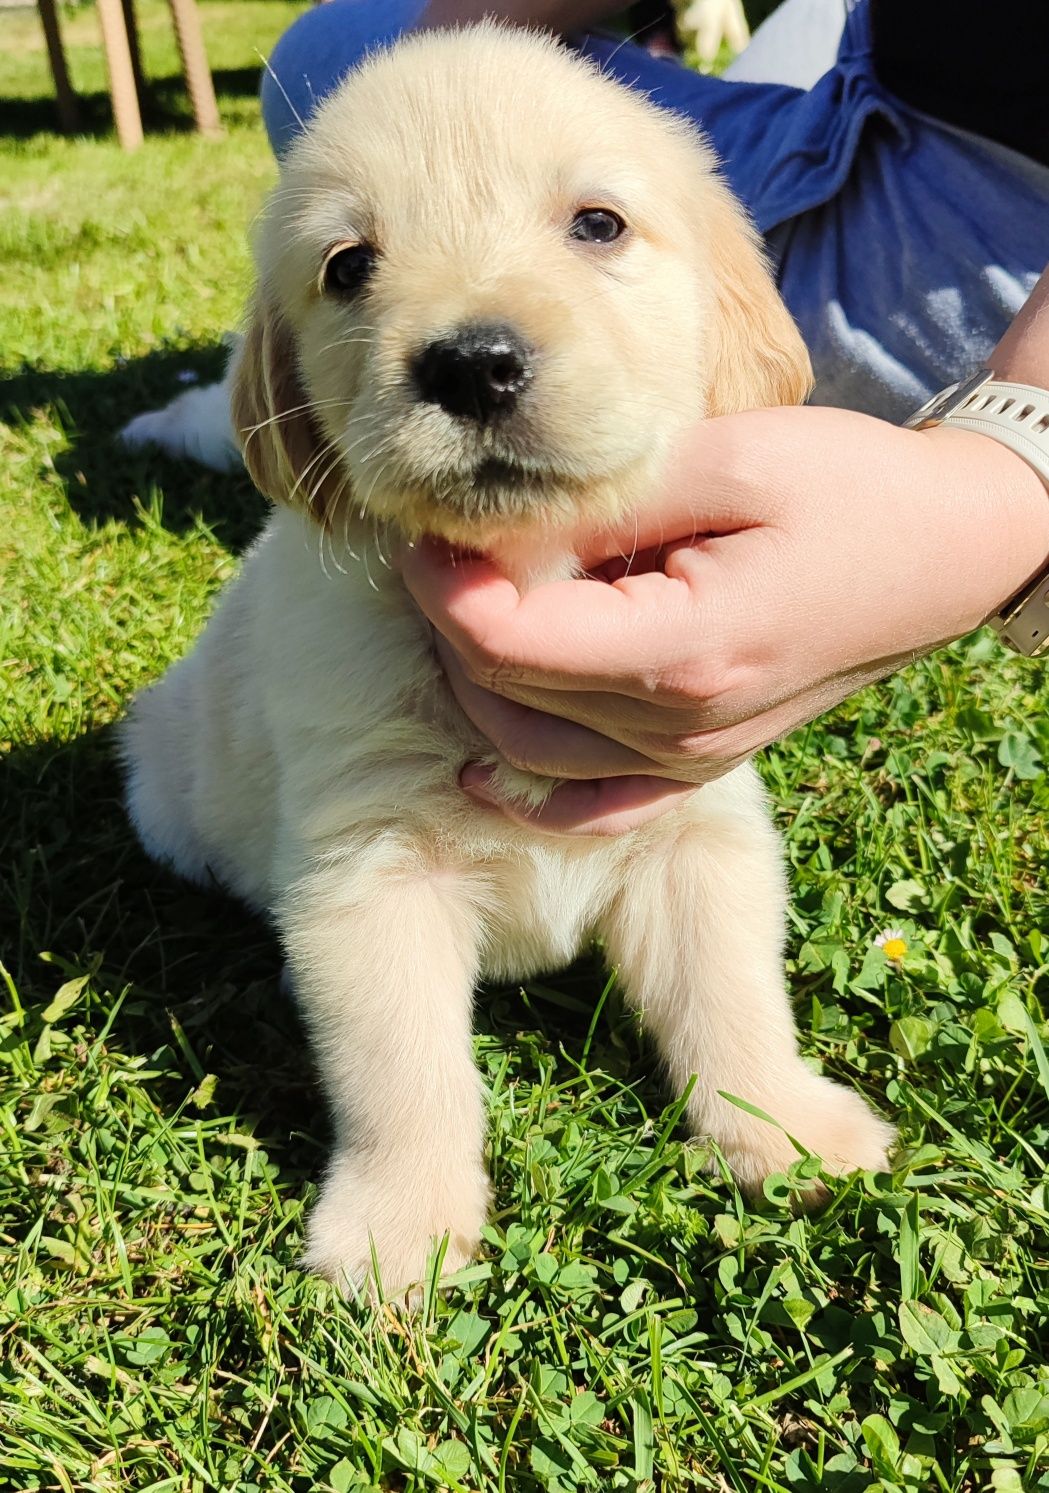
[0,730,638,1179]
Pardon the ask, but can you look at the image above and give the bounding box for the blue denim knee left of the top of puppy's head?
[261,0,425,155]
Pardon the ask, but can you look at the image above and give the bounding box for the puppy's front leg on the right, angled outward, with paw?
[601,785,892,1191]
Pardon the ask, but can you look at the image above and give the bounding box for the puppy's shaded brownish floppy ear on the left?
[230,293,348,524]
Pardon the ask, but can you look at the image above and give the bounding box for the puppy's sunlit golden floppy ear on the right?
[704,184,812,415]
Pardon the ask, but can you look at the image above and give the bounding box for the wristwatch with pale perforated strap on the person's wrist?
[904,369,1049,657]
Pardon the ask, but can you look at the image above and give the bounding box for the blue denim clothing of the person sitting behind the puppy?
[263,0,1049,420]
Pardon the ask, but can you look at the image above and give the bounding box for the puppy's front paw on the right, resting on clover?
[721,1069,894,1203]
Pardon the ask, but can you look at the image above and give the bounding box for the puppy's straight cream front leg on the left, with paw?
[281,853,488,1293]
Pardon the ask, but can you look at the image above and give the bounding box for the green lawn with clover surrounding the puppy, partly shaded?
[0,0,1049,1493]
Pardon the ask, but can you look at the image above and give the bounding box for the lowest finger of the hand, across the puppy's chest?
[460,763,697,838]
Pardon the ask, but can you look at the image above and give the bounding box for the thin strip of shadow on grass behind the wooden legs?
[0,64,261,140]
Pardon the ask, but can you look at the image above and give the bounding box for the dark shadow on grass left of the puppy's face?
[0,345,266,551]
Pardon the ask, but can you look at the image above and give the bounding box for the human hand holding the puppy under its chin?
[403,408,1049,835]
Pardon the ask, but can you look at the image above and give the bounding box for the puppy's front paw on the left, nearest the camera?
[303,1154,489,1297]
